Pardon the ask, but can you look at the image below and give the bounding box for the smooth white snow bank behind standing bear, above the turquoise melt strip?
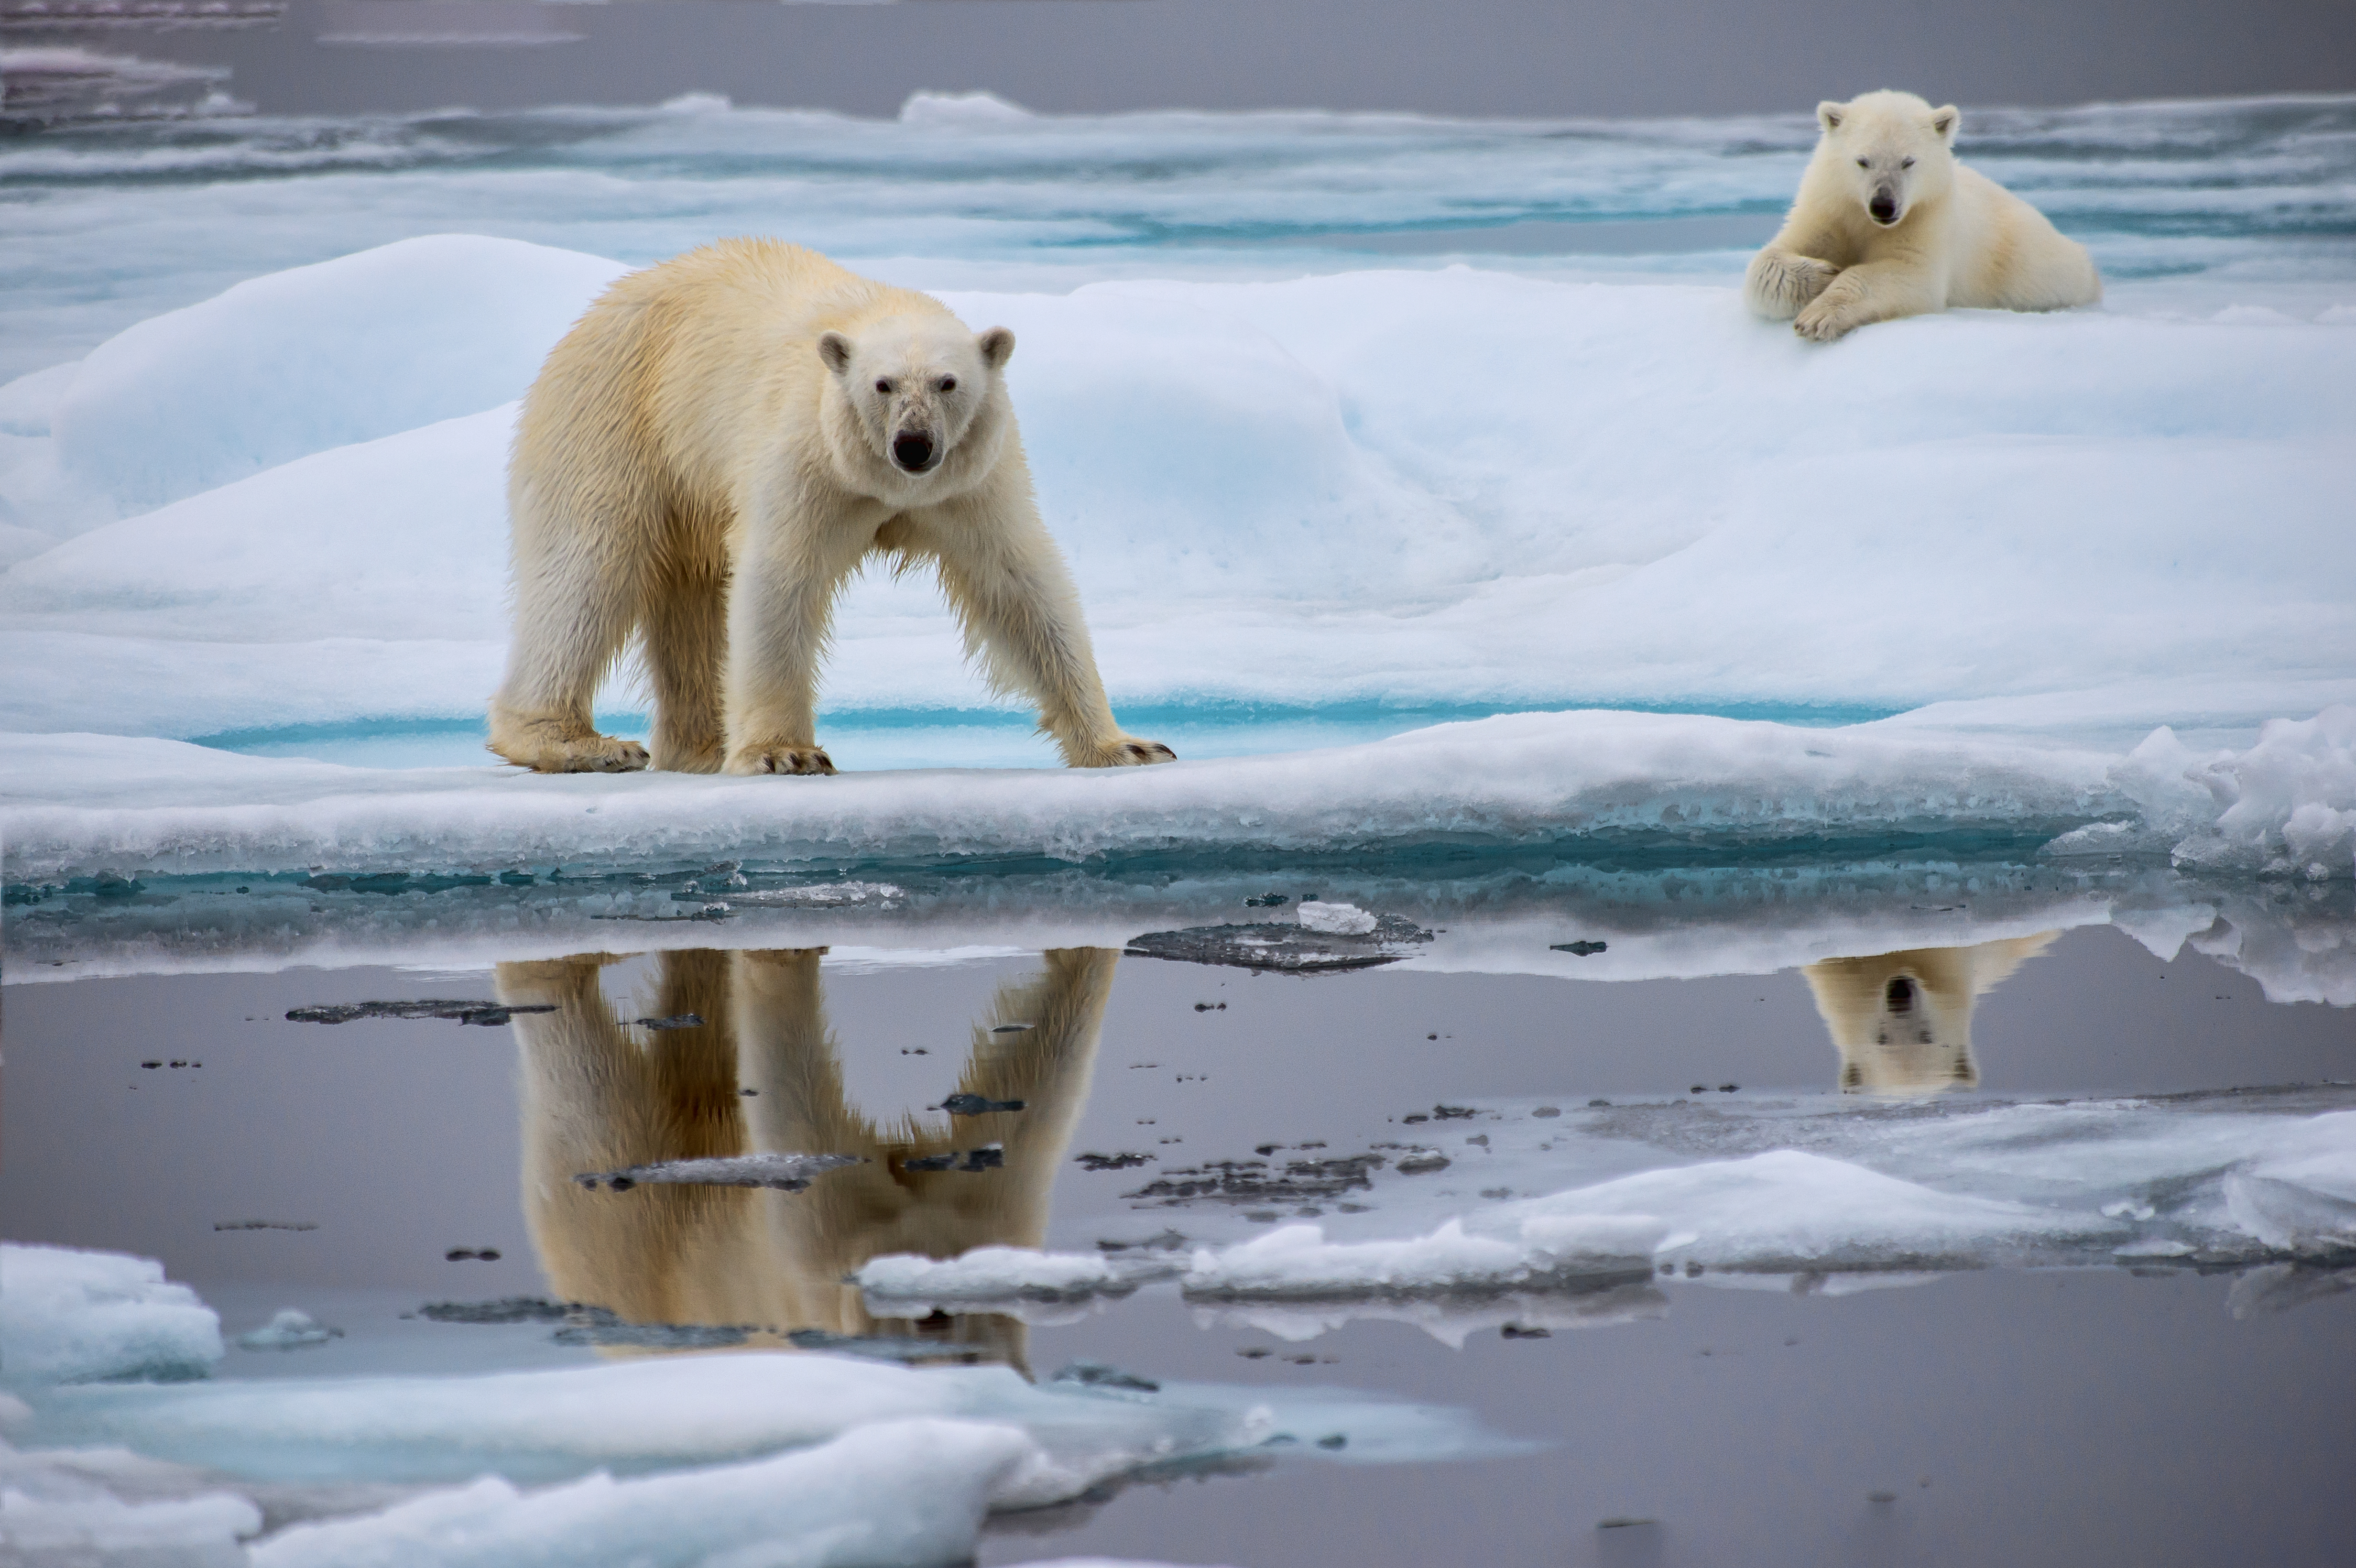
[0,246,2356,753]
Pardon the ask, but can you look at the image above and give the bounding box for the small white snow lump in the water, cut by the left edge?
[0,1243,224,1384]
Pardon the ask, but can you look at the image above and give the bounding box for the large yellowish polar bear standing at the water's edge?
[490,240,1171,774]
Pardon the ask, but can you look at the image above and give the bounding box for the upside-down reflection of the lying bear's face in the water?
[1805,930,2059,1095]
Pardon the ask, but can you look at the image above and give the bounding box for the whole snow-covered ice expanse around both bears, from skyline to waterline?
[0,99,2356,899]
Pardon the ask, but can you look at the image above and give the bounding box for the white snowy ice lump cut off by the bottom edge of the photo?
[252,1420,1039,1568]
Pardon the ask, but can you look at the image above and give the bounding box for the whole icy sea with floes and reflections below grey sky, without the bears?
[0,94,2356,1568]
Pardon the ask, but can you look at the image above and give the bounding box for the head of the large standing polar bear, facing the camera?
[818,311,1015,483]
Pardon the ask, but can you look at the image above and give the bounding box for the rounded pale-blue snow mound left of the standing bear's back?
[52,233,627,511]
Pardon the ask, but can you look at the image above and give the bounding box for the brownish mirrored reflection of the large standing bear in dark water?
[500,949,1119,1365]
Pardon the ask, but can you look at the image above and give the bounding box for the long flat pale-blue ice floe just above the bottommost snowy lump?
[13,1351,1491,1507]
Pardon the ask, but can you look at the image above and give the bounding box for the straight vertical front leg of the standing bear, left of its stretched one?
[721,537,848,774]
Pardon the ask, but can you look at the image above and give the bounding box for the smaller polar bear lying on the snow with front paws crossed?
[1744,92,2102,344]
